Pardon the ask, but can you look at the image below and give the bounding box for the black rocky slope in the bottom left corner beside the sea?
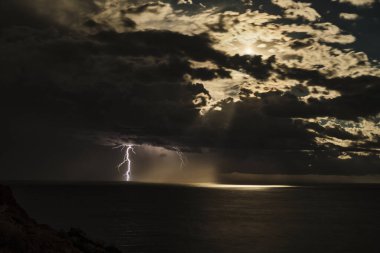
[0,185,120,253]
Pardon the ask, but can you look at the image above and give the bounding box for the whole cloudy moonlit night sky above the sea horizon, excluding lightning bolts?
[0,0,380,182]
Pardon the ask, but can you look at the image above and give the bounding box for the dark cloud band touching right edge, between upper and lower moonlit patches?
[276,68,380,119]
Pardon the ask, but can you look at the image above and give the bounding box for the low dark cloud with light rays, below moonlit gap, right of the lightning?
[183,92,379,150]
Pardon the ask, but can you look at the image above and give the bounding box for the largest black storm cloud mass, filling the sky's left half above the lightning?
[1,7,235,150]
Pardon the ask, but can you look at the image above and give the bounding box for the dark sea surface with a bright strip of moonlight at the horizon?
[7,183,380,253]
